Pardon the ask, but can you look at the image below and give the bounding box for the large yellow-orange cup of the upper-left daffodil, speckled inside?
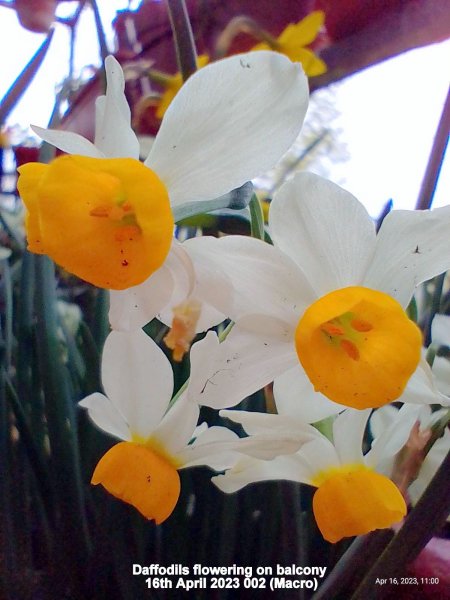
[18,155,174,289]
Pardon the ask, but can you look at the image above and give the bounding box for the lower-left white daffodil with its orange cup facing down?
[79,330,308,523]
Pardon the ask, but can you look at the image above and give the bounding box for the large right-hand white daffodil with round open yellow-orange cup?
[184,173,450,410]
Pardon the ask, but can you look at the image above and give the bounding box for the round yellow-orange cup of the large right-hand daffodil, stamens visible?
[295,286,422,408]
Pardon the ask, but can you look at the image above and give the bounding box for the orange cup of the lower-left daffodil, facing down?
[91,442,180,525]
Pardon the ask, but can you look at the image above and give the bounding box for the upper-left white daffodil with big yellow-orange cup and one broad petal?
[18,52,308,292]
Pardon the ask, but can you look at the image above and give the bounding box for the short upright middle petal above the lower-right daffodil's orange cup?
[333,408,371,465]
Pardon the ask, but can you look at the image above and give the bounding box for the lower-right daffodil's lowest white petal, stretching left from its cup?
[211,455,309,494]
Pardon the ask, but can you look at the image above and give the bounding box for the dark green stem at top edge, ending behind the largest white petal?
[166,0,197,81]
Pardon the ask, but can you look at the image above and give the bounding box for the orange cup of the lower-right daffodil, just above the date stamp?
[312,465,407,543]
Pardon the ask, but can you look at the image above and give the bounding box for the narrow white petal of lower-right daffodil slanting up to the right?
[364,404,422,467]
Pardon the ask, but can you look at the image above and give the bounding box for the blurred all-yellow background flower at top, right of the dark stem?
[251,10,327,77]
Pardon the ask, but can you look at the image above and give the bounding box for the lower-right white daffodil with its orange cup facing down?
[212,405,419,543]
